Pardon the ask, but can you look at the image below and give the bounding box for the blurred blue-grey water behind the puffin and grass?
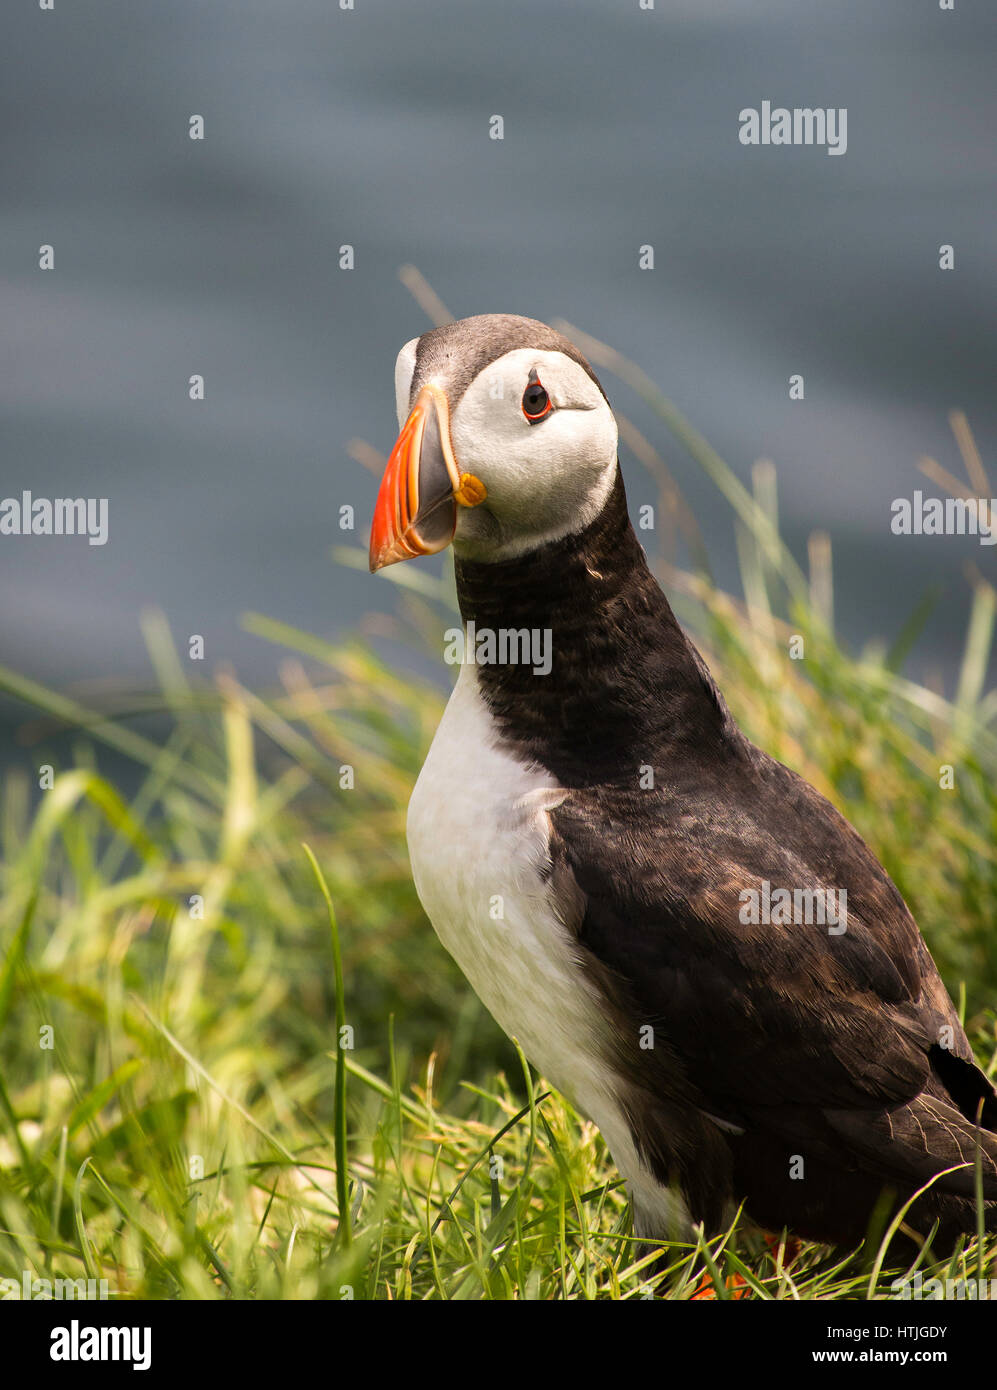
[0,0,997,756]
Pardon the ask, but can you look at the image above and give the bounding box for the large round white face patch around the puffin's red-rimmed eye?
[450,345,617,560]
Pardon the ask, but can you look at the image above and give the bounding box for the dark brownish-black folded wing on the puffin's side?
[551,741,997,1198]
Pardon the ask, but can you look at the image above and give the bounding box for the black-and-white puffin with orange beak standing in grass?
[370,314,997,1248]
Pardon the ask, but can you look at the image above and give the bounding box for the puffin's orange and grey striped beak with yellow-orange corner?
[370,384,485,574]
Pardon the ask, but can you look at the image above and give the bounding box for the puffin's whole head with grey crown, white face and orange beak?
[370,314,616,570]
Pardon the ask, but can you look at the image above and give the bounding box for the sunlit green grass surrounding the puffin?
[0,322,997,1300]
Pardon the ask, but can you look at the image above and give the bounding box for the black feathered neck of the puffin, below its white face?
[456,466,734,785]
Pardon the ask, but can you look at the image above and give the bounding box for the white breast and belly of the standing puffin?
[407,666,683,1233]
